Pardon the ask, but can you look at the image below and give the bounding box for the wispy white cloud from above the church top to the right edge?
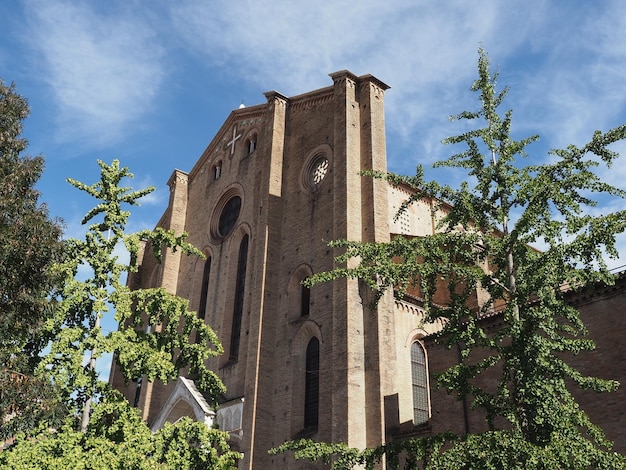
[171,0,626,171]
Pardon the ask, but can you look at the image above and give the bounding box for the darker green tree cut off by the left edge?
[0,79,63,440]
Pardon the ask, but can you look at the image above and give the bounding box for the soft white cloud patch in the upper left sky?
[25,0,164,149]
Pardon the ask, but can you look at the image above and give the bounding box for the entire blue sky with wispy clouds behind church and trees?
[0,0,626,374]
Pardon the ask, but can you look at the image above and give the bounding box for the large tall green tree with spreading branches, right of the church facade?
[278,49,626,469]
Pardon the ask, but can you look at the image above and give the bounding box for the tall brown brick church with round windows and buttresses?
[110,71,624,469]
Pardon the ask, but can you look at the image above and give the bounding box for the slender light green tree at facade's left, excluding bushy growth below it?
[40,160,224,429]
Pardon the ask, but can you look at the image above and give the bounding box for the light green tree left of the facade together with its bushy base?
[0,160,238,469]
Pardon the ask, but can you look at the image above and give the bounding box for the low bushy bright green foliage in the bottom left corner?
[0,392,239,470]
